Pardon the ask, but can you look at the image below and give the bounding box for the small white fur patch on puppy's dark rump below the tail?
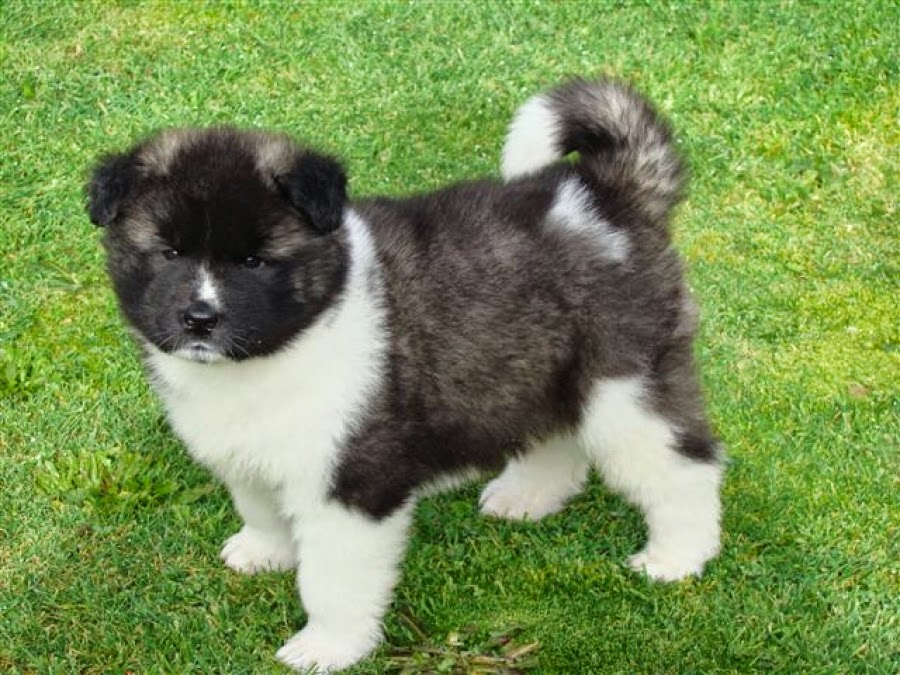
[547,178,631,263]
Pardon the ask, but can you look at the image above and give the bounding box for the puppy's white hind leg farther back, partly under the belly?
[480,436,589,520]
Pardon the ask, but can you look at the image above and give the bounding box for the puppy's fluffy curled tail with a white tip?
[502,79,685,220]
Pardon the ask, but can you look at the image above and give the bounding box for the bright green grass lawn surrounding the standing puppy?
[0,0,900,674]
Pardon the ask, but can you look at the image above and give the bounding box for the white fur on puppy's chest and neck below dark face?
[149,213,386,516]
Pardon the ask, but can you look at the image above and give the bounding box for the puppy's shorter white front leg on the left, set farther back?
[219,482,297,574]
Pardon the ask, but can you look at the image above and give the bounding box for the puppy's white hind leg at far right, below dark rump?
[580,376,722,581]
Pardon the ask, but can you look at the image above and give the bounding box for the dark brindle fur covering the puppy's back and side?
[333,166,705,517]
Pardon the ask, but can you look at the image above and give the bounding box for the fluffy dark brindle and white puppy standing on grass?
[88,80,722,672]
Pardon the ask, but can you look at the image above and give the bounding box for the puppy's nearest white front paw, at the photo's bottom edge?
[275,625,381,673]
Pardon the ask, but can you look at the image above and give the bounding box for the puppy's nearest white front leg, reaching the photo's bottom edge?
[276,502,413,673]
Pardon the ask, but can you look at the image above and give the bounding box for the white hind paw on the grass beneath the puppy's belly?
[479,474,578,520]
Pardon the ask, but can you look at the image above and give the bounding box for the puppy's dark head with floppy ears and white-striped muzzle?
[88,129,347,361]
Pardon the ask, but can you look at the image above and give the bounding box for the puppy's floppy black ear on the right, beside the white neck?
[275,152,347,234]
